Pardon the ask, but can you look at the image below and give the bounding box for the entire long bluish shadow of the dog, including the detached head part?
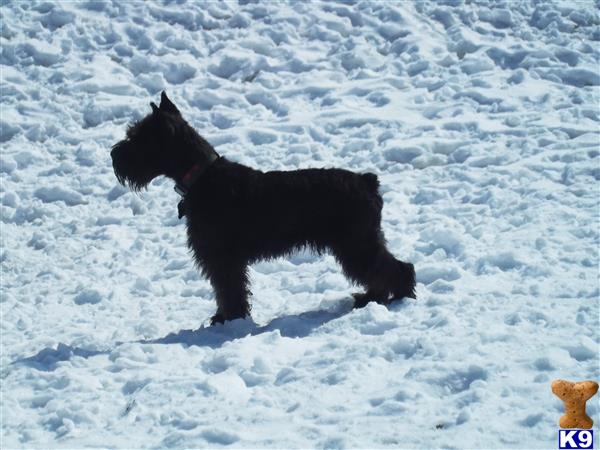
[11,301,352,372]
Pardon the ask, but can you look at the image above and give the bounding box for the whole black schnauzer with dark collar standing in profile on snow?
[111,92,415,324]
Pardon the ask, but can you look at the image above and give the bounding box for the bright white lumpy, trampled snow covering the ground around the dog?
[0,0,600,448]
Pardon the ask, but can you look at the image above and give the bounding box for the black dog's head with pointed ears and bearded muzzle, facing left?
[110,92,185,190]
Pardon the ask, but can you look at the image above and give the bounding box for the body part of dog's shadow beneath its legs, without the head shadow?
[137,302,352,348]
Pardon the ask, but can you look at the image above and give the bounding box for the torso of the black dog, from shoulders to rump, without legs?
[186,158,383,251]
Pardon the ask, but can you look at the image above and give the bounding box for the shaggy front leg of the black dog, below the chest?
[209,261,250,325]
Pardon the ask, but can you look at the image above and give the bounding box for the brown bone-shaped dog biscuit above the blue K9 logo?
[552,380,598,430]
